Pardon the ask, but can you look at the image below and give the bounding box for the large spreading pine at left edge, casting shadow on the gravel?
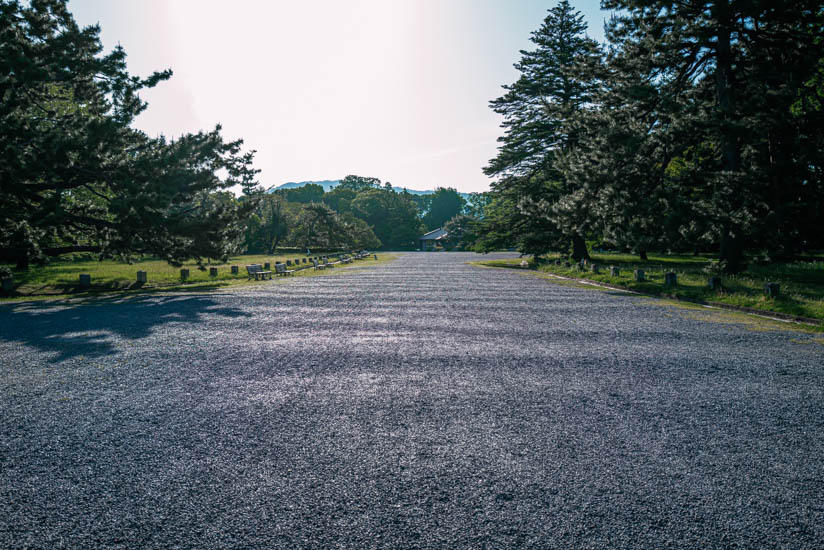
[0,0,256,267]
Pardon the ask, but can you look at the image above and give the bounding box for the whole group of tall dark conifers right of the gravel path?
[469,0,824,272]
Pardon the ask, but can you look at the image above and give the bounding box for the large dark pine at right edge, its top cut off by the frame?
[604,0,822,272]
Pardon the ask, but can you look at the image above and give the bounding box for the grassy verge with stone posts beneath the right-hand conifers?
[478,254,824,328]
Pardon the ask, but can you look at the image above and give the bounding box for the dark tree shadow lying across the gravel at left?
[0,295,244,361]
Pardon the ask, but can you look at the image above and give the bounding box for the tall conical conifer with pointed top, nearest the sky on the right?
[484,0,599,259]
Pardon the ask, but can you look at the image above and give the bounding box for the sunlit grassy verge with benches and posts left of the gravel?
[0,254,395,301]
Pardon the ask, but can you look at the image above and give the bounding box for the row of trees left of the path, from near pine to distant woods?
[0,0,464,268]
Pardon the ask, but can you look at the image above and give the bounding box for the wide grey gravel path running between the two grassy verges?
[0,253,824,549]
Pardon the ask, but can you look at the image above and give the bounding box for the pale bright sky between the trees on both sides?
[69,0,609,193]
